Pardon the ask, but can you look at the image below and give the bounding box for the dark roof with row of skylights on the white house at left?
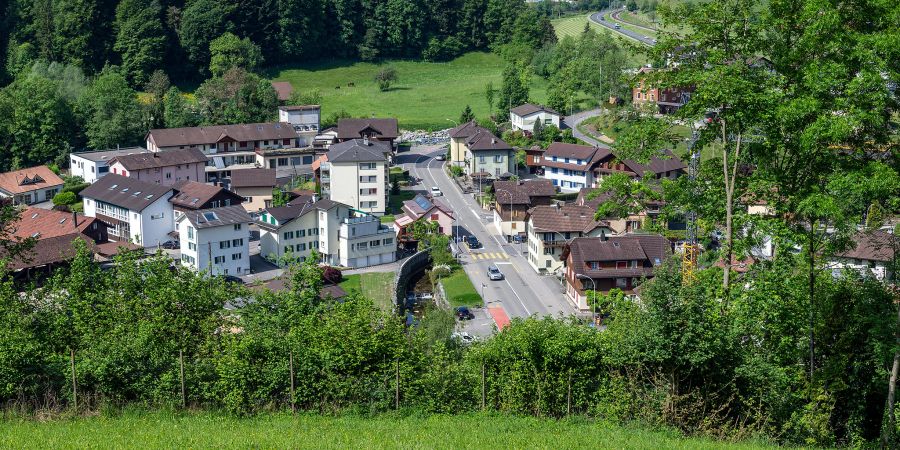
[80,173,172,211]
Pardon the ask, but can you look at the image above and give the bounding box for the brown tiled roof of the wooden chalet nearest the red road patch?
[563,234,671,278]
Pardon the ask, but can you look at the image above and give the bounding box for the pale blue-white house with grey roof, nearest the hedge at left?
[175,205,253,276]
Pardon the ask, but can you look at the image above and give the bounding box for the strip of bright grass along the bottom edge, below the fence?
[0,411,767,449]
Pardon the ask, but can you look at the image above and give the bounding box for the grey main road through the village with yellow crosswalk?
[395,146,576,321]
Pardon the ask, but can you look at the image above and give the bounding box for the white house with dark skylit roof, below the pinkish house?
[80,174,175,247]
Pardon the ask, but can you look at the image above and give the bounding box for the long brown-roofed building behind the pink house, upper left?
[147,122,300,181]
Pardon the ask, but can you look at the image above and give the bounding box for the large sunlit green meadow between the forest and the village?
[272,52,547,130]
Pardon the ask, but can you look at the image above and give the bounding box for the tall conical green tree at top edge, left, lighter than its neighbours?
[113,0,166,86]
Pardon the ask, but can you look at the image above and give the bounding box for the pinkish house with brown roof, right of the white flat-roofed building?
[109,148,207,186]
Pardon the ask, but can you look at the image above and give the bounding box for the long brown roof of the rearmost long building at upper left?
[147,122,297,147]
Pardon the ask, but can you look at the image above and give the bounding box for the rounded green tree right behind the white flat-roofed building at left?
[77,67,144,149]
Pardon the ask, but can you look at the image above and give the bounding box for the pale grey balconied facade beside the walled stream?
[337,216,397,269]
